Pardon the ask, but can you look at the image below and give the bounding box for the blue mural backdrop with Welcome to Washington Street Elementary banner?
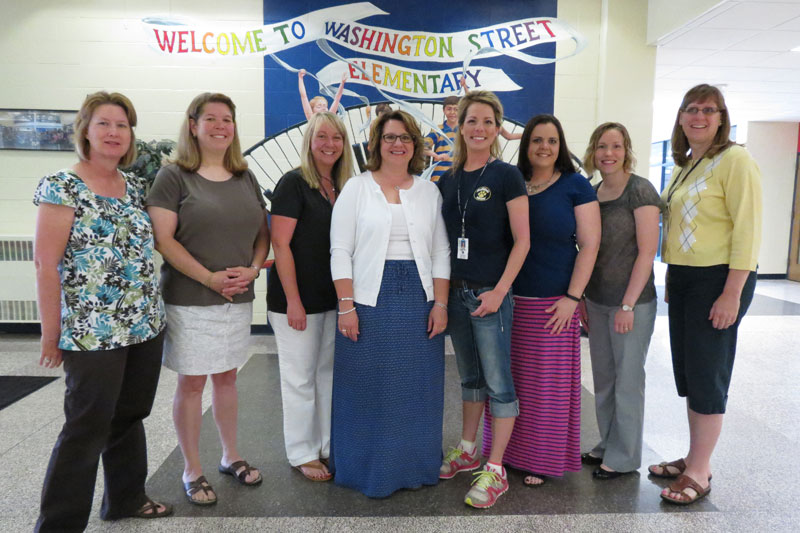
[144,0,585,135]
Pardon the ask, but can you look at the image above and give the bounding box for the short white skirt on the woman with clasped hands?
[163,302,253,376]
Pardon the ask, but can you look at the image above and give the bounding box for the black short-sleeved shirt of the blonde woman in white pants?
[267,169,336,314]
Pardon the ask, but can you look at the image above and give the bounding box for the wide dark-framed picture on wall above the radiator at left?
[0,109,78,152]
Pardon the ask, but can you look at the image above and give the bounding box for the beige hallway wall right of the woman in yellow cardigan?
[747,122,798,274]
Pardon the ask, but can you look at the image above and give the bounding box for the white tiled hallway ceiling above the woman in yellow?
[653,0,800,141]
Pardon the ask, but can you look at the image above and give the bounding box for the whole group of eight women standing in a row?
[35,80,761,531]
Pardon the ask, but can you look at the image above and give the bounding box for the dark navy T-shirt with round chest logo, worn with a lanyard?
[436,161,527,286]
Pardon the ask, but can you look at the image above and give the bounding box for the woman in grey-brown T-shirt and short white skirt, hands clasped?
[147,93,269,505]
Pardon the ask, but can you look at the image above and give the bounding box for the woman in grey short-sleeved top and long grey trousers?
[581,122,661,479]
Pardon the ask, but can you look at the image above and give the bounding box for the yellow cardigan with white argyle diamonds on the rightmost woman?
[661,146,761,270]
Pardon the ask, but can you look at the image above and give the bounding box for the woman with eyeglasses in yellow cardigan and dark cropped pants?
[649,84,761,505]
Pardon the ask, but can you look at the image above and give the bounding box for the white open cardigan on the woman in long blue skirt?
[331,171,450,307]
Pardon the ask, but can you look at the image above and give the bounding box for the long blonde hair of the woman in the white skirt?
[169,93,247,175]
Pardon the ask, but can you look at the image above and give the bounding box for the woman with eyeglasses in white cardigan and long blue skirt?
[331,111,450,498]
